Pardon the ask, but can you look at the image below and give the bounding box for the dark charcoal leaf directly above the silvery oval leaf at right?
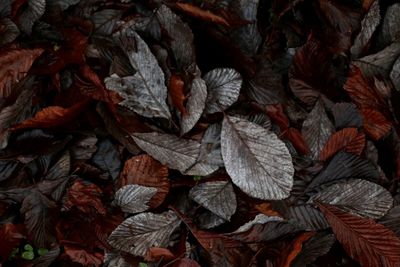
[307,152,380,190]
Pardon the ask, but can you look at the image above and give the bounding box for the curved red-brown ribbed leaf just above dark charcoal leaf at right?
[319,128,365,161]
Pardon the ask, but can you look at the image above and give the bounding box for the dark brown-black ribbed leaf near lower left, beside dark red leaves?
[20,190,56,247]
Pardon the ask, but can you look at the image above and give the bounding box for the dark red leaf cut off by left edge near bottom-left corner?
[0,223,25,263]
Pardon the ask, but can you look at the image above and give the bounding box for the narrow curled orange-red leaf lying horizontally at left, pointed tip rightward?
[13,101,89,130]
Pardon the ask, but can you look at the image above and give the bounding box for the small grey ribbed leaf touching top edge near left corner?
[18,0,46,35]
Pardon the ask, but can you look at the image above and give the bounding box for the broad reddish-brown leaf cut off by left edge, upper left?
[0,48,44,98]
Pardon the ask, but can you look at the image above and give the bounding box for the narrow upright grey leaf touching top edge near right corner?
[350,1,381,58]
